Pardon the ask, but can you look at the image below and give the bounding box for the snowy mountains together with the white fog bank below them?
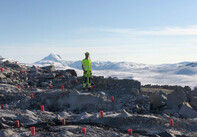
[35,54,197,87]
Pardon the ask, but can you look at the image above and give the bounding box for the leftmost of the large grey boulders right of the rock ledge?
[150,91,167,109]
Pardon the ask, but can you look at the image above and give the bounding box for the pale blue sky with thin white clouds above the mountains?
[0,0,197,64]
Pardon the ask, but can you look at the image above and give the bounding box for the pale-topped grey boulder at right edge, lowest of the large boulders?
[179,102,197,118]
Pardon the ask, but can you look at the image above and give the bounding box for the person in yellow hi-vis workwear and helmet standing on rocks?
[82,52,92,90]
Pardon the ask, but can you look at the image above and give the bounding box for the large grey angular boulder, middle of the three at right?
[167,87,187,108]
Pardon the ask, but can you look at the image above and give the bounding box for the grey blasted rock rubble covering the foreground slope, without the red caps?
[0,61,197,137]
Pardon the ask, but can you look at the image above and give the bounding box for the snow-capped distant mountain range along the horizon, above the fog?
[34,53,197,73]
